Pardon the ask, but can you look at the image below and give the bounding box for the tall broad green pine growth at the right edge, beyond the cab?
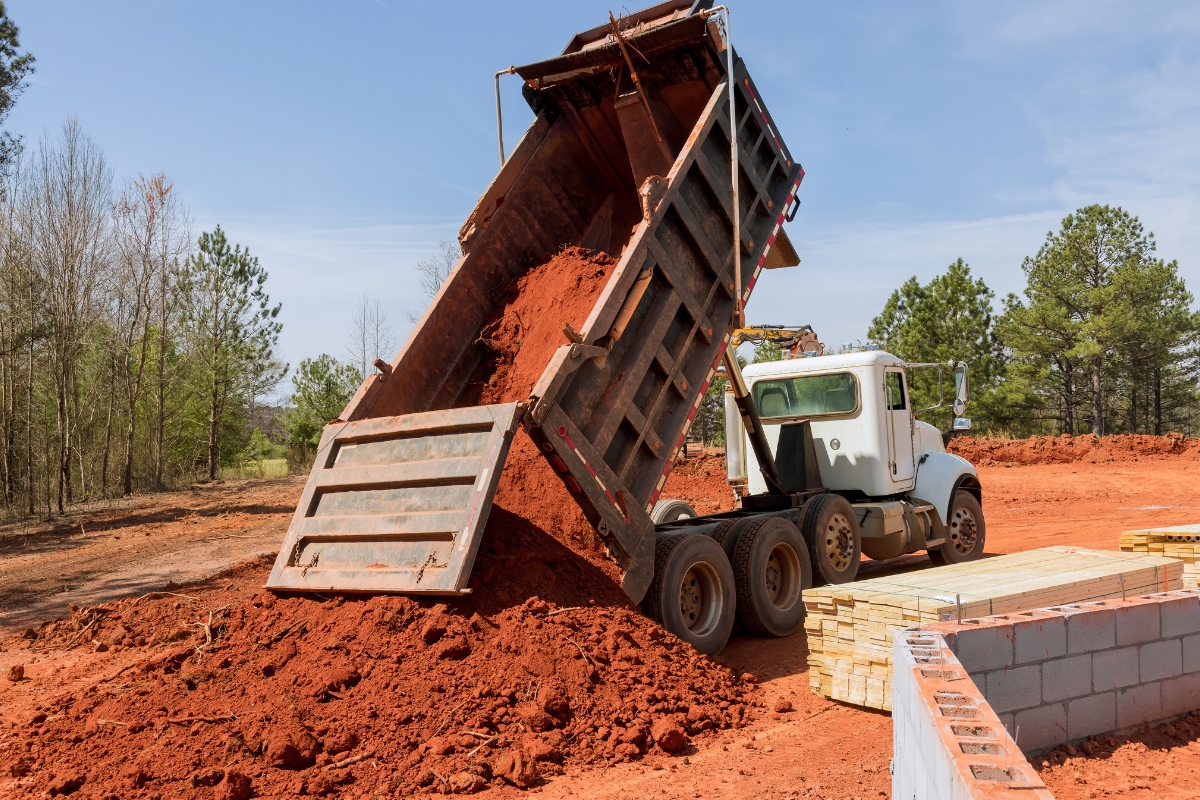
[997,205,1200,435]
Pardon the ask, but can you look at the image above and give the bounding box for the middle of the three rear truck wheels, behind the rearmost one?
[731,517,812,637]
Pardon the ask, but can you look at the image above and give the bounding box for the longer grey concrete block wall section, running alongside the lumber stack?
[925,589,1200,753]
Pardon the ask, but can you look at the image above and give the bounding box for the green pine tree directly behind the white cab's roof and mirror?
[866,258,1008,429]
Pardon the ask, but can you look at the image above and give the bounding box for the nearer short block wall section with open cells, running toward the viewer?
[892,628,1052,800]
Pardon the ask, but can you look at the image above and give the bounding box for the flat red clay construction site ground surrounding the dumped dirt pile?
[0,438,1200,799]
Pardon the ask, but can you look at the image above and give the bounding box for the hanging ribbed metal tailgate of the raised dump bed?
[266,403,522,594]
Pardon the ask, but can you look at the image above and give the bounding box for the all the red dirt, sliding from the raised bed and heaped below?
[6,248,755,800]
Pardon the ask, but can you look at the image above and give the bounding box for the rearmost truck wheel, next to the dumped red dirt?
[642,534,737,655]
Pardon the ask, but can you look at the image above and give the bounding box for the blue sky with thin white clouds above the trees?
[7,0,1200,386]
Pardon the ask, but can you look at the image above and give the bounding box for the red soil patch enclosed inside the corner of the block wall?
[1032,714,1200,800]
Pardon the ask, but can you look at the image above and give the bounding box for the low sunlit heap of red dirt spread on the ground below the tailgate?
[0,561,756,799]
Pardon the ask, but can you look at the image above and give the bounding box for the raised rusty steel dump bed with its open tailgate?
[268,2,804,602]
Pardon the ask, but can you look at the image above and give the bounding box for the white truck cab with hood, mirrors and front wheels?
[725,350,985,582]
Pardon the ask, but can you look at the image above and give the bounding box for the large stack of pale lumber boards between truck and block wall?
[804,547,1183,710]
